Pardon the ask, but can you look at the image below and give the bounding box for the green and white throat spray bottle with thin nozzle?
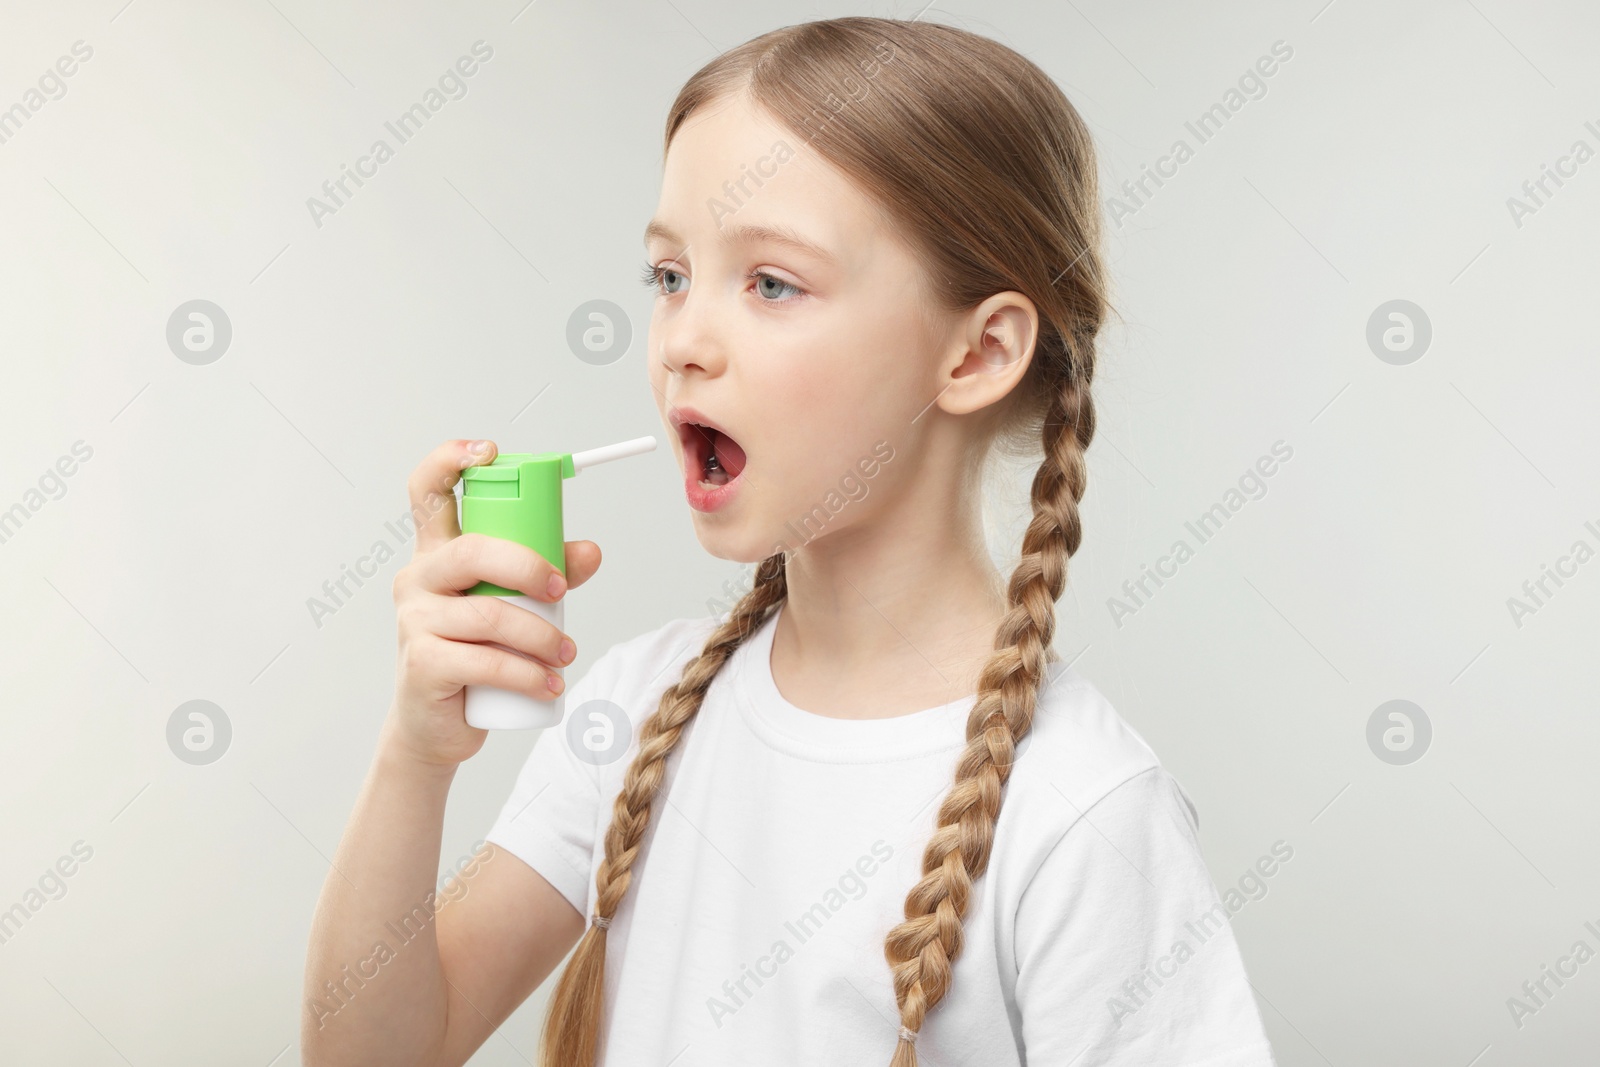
[461,437,656,729]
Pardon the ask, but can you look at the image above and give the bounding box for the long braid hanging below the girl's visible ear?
[883,355,1094,1067]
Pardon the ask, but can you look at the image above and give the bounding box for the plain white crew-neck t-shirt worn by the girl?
[486,613,1274,1067]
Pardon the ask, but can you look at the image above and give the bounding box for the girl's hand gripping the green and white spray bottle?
[384,440,600,768]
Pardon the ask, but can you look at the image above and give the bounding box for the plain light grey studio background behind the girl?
[0,0,1600,1067]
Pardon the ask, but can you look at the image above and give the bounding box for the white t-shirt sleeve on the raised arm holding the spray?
[485,648,616,915]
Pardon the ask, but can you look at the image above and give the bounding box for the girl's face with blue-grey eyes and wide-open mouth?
[645,94,942,563]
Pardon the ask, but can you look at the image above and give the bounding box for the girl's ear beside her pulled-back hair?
[936,291,1038,414]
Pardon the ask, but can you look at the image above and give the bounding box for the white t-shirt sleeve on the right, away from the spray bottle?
[1016,766,1274,1067]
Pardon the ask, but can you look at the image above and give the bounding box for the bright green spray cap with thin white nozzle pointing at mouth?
[461,437,656,597]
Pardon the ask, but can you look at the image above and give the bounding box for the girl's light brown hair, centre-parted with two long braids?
[539,18,1107,1067]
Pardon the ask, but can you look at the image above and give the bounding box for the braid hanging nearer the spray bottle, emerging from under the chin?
[539,552,789,1067]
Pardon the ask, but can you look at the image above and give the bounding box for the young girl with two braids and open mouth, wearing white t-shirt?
[304,18,1272,1067]
